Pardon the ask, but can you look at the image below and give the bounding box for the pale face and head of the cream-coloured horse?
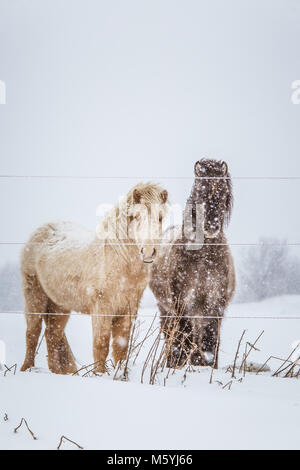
[127,183,168,263]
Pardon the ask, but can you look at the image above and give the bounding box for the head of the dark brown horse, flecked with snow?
[188,159,233,238]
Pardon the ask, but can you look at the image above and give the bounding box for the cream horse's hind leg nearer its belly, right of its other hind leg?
[45,301,77,374]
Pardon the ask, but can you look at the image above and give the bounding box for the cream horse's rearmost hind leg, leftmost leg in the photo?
[21,274,48,371]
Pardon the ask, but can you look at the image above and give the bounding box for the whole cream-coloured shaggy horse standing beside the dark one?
[21,183,168,374]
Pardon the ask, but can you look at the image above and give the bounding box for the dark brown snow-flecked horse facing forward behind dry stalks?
[150,159,235,368]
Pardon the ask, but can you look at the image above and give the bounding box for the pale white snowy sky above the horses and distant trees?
[0,0,300,261]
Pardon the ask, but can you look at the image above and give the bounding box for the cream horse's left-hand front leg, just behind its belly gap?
[92,308,112,373]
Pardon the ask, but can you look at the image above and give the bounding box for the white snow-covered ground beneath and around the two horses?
[0,296,300,449]
